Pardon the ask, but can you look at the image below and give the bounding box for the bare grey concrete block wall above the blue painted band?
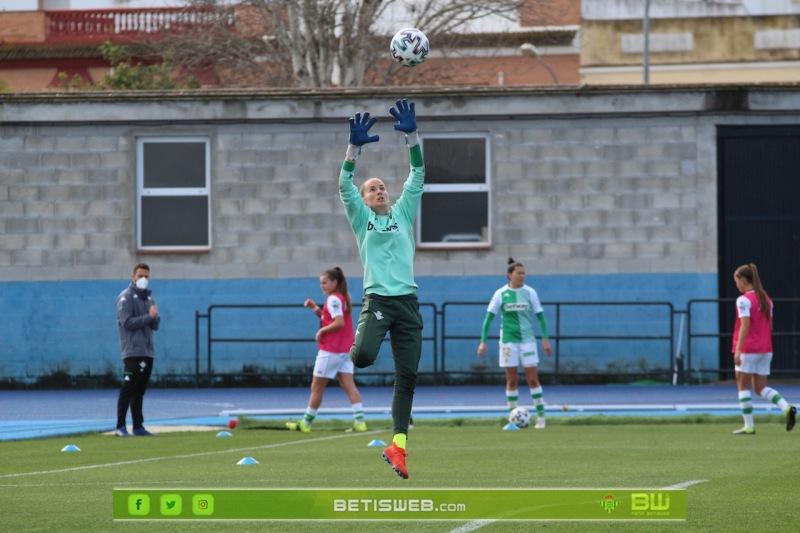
[0,88,732,281]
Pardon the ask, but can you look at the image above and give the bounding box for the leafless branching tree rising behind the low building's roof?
[150,0,530,88]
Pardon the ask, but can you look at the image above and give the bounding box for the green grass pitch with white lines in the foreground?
[0,416,800,533]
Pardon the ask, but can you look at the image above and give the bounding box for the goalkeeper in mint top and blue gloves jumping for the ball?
[339,100,425,479]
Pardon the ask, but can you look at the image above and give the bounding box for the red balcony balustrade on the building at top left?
[46,8,234,44]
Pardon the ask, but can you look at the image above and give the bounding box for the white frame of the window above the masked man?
[136,136,212,252]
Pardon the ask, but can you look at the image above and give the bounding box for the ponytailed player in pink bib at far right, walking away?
[731,263,797,435]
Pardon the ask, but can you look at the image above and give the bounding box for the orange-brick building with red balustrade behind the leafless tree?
[0,0,580,92]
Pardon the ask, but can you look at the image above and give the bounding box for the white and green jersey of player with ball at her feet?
[486,284,546,342]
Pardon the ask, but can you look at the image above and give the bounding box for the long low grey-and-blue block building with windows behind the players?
[0,86,800,380]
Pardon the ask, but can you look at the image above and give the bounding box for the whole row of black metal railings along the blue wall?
[194,298,800,385]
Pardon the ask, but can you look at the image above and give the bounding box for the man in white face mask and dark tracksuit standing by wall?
[115,263,161,437]
